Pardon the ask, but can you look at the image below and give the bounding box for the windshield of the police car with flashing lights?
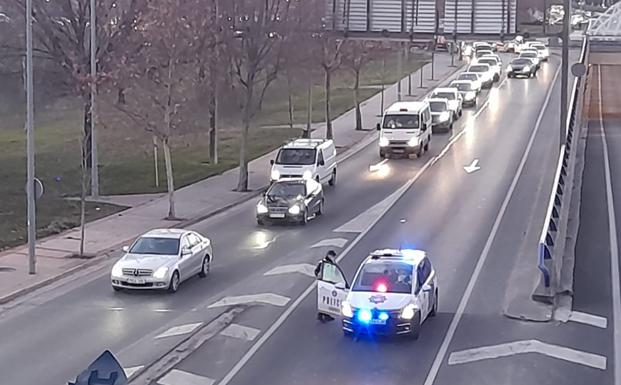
[352,261,414,294]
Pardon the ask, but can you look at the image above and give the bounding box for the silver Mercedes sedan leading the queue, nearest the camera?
[110,229,213,293]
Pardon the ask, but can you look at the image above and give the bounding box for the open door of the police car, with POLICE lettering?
[317,261,349,316]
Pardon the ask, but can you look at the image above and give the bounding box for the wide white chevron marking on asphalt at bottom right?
[448,340,606,370]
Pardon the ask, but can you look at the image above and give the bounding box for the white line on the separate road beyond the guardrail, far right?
[597,65,621,383]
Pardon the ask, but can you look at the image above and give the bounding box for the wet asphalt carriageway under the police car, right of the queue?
[161,53,621,385]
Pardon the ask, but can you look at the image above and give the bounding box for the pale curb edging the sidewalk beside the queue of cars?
[0,55,466,305]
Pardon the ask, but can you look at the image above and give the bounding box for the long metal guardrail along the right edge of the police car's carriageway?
[533,36,589,301]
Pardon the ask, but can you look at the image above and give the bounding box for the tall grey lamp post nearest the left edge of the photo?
[26,0,37,274]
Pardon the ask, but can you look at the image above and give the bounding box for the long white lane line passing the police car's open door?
[218,60,506,385]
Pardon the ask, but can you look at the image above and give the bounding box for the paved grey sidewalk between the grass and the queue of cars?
[0,53,461,303]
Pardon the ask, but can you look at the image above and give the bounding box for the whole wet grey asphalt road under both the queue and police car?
[0,51,609,385]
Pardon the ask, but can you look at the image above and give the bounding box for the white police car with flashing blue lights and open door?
[317,249,438,339]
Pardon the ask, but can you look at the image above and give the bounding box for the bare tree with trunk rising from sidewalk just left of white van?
[220,0,290,191]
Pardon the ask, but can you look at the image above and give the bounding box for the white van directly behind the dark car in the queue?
[270,139,336,186]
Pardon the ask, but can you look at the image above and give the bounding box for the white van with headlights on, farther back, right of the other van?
[377,101,432,158]
